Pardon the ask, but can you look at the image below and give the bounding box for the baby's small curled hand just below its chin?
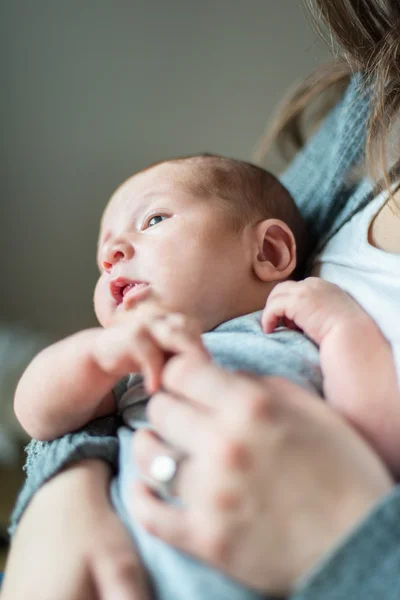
[94,301,206,394]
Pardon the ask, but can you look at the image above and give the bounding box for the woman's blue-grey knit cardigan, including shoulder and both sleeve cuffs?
[10,74,400,600]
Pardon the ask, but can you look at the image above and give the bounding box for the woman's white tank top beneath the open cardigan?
[312,191,400,382]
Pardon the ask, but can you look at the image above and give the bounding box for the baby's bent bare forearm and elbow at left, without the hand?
[14,328,118,440]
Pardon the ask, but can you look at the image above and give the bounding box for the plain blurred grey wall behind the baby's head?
[0,0,329,335]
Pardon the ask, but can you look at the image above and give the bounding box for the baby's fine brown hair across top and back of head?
[145,153,307,264]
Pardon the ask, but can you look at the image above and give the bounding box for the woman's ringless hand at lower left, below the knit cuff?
[1,460,150,600]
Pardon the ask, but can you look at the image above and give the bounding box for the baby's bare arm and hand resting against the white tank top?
[262,277,400,475]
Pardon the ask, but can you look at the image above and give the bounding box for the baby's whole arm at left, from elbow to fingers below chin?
[14,305,206,440]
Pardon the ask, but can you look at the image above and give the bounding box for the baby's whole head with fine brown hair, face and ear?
[94,155,304,331]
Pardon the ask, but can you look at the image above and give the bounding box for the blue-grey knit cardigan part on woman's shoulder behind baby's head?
[281,73,372,258]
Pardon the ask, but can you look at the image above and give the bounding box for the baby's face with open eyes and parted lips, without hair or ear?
[94,163,250,331]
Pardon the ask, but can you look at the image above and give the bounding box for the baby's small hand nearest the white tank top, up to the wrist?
[261,277,372,345]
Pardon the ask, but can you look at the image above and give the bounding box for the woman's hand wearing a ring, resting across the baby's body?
[132,355,393,594]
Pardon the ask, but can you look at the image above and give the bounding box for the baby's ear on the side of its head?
[253,219,296,281]
